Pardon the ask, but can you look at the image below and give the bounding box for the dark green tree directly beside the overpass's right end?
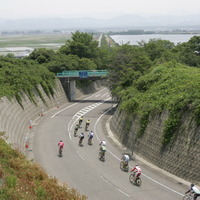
[109,44,152,93]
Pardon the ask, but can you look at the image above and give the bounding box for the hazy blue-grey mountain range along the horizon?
[0,15,200,31]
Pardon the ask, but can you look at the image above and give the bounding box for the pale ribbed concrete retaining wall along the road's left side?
[0,80,103,156]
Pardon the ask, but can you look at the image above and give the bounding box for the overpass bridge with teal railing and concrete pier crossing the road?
[56,70,109,101]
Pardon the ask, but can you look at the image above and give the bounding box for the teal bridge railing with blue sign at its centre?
[57,70,109,78]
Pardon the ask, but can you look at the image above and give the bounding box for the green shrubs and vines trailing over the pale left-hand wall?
[0,56,55,107]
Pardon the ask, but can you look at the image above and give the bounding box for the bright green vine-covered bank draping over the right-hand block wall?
[117,62,200,146]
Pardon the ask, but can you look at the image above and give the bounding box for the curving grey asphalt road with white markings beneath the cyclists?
[33,88,188,200]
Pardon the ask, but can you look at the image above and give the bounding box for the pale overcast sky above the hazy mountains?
[0,0,200,19]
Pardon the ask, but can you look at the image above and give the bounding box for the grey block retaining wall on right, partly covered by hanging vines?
[110,109,200,185]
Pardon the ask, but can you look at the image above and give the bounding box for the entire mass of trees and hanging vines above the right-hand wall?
[110,36,200,147]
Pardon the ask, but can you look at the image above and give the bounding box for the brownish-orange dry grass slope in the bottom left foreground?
[0,138,87,200]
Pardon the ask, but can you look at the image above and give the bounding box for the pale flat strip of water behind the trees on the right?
[110,34,200,45]
